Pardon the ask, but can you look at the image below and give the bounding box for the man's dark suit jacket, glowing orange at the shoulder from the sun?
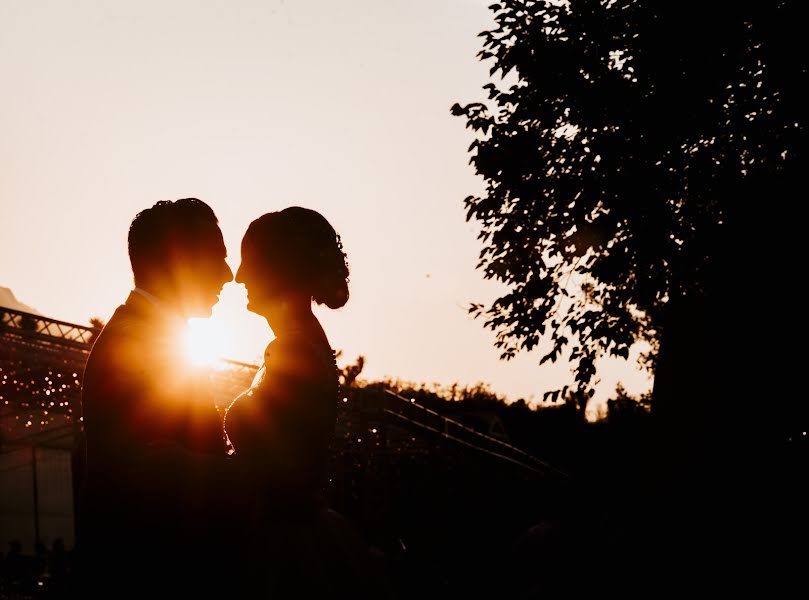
[77,292,228,592]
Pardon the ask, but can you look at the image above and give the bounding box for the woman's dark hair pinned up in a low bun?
[245,206,348,308]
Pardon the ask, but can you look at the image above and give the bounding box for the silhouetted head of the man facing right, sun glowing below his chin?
[129,198,233,317]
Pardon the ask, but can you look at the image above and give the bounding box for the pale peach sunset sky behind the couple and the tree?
[0,0,650,412]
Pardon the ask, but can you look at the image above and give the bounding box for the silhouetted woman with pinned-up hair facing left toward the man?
[225,206,385,598]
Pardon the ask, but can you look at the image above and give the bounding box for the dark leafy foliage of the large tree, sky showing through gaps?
[452,0,805,398]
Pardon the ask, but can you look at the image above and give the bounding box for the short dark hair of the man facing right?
[129,198,219,285]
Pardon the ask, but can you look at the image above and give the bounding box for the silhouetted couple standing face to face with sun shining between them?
[77,198,384,598]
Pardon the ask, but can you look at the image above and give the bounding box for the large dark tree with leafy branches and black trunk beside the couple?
[452,0,809,584]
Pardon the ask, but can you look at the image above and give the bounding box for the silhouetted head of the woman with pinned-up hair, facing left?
[236,206,348,313]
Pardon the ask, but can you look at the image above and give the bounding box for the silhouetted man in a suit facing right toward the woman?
[77,198,233,596]
